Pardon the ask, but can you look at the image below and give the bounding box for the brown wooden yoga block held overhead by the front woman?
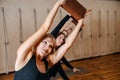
[62,0,86,20]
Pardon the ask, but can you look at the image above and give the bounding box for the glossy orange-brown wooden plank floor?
[0,53,120,80]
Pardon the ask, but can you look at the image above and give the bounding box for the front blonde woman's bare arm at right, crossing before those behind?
[50,19,83,64]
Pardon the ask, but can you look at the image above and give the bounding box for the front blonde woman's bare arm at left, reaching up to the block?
[17,0,64,61]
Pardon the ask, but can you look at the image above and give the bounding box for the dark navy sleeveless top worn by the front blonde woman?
[14,55,49,80]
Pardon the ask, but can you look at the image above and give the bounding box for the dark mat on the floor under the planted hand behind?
[56,68,88,79]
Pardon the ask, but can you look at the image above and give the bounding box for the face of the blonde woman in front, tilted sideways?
[36,38,54,57]
